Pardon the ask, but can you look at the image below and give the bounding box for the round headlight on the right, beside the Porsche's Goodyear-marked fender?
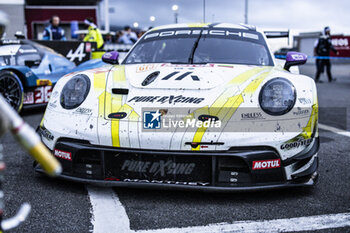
[259,78,296,116]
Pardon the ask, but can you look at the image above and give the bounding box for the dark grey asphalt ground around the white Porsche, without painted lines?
[0,62,350,232]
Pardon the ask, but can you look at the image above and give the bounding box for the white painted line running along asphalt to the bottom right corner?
[136,213,350,233]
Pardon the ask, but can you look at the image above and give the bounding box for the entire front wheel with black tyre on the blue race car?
[0,70,24,112]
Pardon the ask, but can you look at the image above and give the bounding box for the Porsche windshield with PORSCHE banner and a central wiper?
[124,29,273,66]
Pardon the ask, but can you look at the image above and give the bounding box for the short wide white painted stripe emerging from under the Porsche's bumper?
[86,185,130,233]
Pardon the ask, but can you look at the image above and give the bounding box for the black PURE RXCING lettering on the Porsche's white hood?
[128,95,205,105]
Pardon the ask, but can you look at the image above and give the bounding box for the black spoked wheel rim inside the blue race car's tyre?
[0,74,22,110]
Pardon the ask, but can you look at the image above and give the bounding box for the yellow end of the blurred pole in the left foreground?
[29,142,62,176]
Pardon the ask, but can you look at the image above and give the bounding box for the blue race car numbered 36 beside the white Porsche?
[0,40,75,111]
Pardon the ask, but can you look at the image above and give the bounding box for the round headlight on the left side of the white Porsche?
[60,74,90,109]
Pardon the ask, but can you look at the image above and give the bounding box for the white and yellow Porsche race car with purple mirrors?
[36,23,319,191]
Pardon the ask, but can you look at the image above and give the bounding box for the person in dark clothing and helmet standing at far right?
[314,27,338,83]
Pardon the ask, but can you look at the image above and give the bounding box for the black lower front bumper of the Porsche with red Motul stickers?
[35,138,319,191]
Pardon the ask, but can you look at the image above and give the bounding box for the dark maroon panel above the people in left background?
[25,6,97,39]
